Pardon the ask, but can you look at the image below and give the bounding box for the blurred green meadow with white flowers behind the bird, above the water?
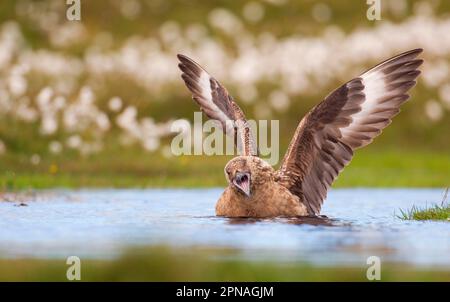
[0,0,450,189]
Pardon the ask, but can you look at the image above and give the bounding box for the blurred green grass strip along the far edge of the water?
[0,147,450,190]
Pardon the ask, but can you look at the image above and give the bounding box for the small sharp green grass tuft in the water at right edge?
[397,188,450,221]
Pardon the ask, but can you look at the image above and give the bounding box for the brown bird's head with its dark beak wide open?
[225,156,273,197]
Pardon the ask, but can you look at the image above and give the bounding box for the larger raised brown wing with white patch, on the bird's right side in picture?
[277,49,423,215]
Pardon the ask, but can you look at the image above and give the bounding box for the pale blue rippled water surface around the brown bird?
[0,189,450,269]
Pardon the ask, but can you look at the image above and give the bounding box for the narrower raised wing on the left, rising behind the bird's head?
[177,54,258,155]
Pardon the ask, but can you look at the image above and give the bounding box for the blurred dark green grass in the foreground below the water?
[0,247,450,281]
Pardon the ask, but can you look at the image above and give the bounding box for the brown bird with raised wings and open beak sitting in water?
[178,49,423,217]
